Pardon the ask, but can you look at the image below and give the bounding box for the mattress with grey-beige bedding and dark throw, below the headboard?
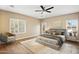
[36,28,66,48]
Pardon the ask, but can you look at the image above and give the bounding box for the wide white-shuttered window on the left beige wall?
[10,18,26,34]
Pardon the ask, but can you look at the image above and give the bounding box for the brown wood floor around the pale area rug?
[0,38,79,54]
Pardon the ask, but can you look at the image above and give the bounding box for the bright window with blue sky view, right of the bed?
[66,19,78,36]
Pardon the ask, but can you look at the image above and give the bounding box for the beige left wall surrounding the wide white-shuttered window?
[0,10,40,39]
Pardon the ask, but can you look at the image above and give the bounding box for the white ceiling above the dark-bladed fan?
[0,5,79,19]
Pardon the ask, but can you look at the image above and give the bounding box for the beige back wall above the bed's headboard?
[42,12,79,36]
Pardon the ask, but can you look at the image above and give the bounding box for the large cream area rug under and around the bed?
[21,38,78,54]
